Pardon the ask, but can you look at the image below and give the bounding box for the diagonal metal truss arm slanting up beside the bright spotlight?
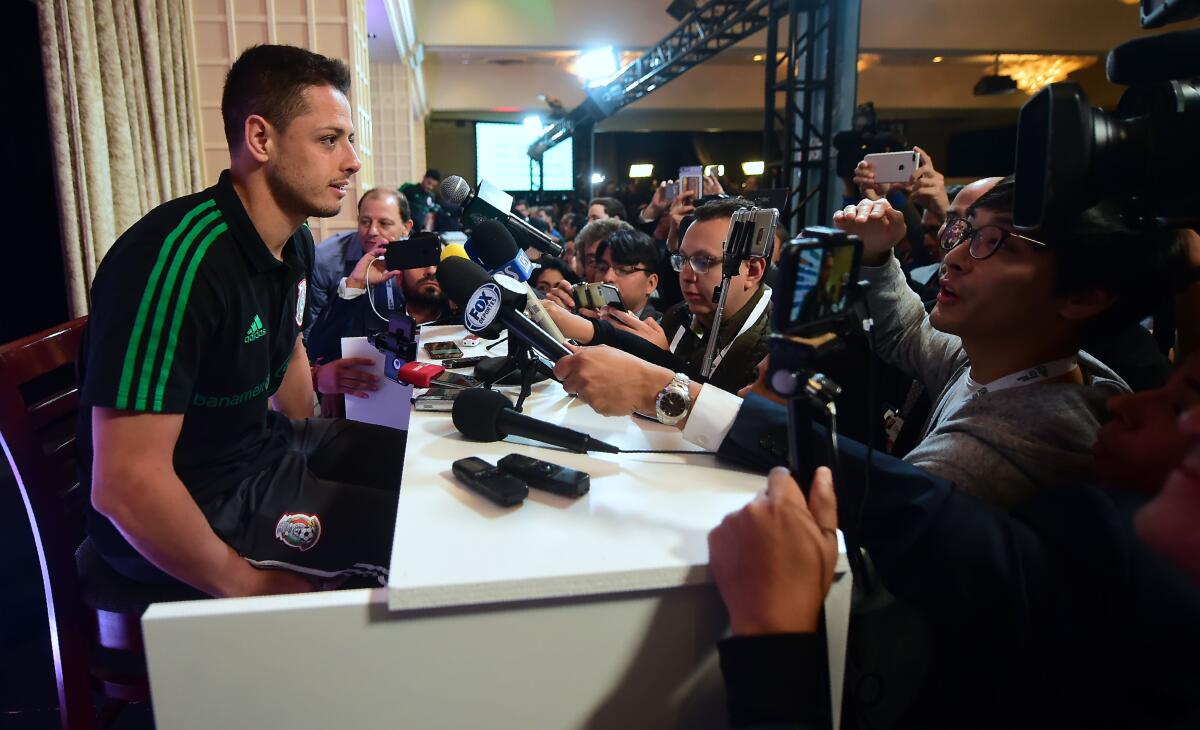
[529,0,780,160]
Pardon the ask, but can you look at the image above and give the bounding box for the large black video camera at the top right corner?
[1013,0,1200,231]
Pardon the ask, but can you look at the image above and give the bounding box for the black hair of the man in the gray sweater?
[967,175,1184,329]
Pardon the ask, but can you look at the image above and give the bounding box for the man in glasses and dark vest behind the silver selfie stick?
[546,198,770,393]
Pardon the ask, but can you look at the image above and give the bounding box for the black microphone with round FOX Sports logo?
[438,256,571,363]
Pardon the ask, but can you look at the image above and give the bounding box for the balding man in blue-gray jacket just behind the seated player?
[304,187,413,343]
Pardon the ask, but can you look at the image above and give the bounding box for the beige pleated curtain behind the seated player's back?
[37,0,203,317]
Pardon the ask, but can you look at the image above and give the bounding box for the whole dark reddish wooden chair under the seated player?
[0,317,203,730]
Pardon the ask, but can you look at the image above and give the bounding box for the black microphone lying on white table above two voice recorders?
[451,388,620,454]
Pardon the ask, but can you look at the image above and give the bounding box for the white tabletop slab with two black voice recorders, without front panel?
[388,328,764,610]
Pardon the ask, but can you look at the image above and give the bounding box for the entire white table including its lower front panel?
[143,330,854,729]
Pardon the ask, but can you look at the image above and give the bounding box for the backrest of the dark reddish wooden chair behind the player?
[0,317,94,728]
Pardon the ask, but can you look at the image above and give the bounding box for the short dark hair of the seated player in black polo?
[221,46,350,151]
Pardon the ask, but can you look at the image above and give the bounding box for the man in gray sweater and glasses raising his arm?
[834,178,1165,507]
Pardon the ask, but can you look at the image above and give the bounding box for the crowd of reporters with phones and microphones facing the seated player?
[302,135,1200,726]
